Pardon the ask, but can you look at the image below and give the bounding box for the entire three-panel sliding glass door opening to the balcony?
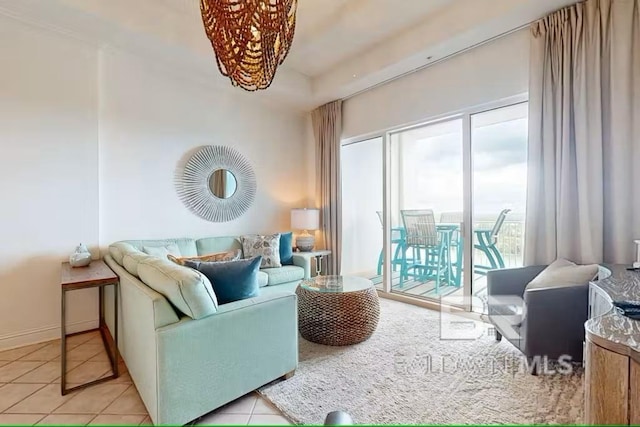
[342,102,527,312]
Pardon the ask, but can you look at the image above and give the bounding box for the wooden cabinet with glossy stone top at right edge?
[584,266,640,424]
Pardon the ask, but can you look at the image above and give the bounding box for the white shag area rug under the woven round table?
[260,299,583,424]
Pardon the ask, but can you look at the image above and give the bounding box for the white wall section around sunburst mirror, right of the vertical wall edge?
[100,51,309,245]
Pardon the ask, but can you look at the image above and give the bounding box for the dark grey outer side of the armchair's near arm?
[521,284,589,362]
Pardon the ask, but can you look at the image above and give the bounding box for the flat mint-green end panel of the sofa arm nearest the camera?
[154,292,298,425]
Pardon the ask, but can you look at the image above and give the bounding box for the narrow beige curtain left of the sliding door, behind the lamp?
[311,101,342,274]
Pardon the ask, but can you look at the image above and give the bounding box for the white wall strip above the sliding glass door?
[342,29,529,139]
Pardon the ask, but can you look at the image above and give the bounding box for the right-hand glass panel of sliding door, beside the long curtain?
[471,102,528,311]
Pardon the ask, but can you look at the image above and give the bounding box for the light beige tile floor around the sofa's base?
[0,332,291,425]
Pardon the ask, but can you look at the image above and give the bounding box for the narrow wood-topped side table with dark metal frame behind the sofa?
[60,260,119,396]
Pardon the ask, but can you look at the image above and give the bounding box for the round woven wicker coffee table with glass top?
[296,276,380,345]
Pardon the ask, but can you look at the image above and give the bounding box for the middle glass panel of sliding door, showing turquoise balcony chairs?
[389,119,464,301]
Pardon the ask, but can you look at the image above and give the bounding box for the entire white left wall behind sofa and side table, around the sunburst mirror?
[0,16,311,350]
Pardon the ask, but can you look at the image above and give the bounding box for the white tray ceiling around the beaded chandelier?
[0,0,575,111]
